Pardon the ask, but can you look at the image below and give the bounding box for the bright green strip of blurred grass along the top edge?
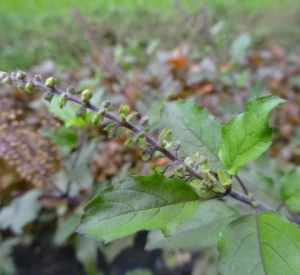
[0,0,299,14]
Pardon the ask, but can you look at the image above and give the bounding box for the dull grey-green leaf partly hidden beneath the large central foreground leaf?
[146,200,239,249]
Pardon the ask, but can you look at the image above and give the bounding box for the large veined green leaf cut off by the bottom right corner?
[218,211,300,275]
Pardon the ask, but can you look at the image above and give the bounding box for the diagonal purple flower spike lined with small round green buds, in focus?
[0,71,227,197]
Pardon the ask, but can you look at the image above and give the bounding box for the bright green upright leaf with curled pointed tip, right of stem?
[219,95,285,175]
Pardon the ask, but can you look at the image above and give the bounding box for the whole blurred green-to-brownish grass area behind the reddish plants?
[0,0,300,70]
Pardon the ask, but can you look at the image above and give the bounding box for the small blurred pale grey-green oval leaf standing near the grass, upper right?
[230,33,252,62]
